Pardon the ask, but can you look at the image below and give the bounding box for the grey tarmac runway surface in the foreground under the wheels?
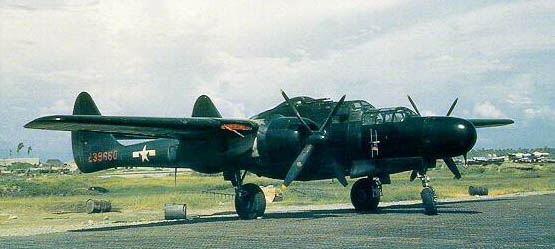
[0,194,555,248]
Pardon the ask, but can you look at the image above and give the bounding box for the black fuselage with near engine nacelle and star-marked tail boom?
[120,97,476,181]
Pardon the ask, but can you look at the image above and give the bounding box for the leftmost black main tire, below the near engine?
[235,183,266,220]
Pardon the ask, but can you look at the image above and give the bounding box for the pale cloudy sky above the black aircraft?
[0,0,555,160]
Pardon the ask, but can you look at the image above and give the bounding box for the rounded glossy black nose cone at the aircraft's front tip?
[423,117,477,157]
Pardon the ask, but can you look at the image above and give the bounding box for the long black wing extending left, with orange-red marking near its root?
[25,115,258,139]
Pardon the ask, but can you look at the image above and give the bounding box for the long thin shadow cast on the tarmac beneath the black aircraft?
[69,198,508,232]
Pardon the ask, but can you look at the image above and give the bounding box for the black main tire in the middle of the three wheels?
[351,178,381,212]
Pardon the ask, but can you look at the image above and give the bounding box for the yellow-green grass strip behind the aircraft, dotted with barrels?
[0,163,555,233]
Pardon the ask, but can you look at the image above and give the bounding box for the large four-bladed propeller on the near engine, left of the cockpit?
[281,90,347,192]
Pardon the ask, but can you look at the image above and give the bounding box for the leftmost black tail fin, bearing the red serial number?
[71,92,123,173]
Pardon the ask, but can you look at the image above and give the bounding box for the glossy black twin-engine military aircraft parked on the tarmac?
[25,91,513,219]
